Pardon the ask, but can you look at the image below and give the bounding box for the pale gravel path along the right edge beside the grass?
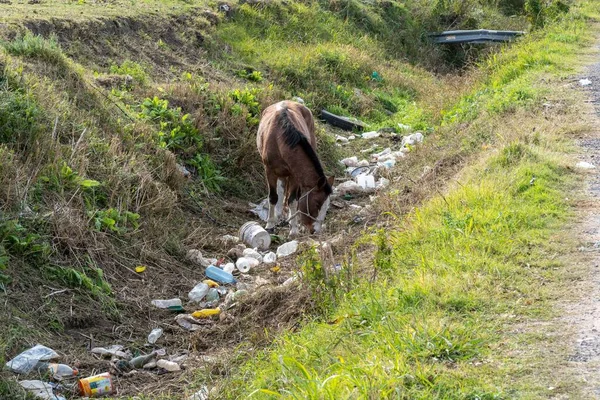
[552,45,600,399]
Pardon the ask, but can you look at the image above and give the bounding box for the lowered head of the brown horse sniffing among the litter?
[298,176,334,235]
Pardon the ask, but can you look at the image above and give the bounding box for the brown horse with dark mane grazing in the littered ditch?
[256,101,334,237]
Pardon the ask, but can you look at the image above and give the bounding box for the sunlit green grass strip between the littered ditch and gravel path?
[219,2,599,399]
